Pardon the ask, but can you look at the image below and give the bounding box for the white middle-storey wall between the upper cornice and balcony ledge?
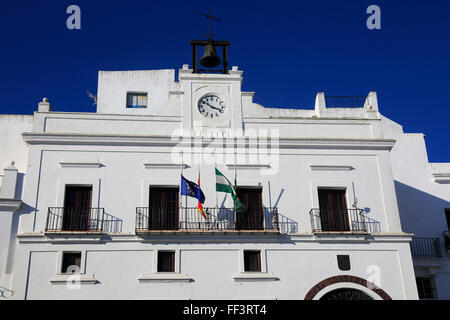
[14,146,401,232]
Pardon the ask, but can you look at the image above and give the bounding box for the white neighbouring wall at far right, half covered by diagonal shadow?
[384,115,450,299]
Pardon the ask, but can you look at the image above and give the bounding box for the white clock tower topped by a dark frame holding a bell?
[178,25,243,132]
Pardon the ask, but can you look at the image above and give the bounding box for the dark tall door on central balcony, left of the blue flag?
[149,187,179,230]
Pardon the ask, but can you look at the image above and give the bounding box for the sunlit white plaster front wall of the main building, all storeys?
[1,68,417,299]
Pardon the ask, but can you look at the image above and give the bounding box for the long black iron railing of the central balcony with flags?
[136,207,279,233]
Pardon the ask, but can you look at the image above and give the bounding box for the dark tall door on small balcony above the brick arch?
[319,189,350,231]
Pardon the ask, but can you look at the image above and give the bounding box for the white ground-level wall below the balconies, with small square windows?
[14,240,416,300]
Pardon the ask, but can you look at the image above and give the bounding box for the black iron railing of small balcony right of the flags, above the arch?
[309,209,380,233]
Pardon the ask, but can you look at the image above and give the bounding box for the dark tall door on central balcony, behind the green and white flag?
[236,187,264,230]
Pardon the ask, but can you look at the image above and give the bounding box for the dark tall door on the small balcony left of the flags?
[62,186,92,231]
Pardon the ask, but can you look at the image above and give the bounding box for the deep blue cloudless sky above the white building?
[0,0,450,162]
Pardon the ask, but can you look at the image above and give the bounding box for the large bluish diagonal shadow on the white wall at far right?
[394,181,450,237]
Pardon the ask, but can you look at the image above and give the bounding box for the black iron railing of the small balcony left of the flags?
[45,207,105,232]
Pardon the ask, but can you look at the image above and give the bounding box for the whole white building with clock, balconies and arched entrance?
[0,51,450,300]
